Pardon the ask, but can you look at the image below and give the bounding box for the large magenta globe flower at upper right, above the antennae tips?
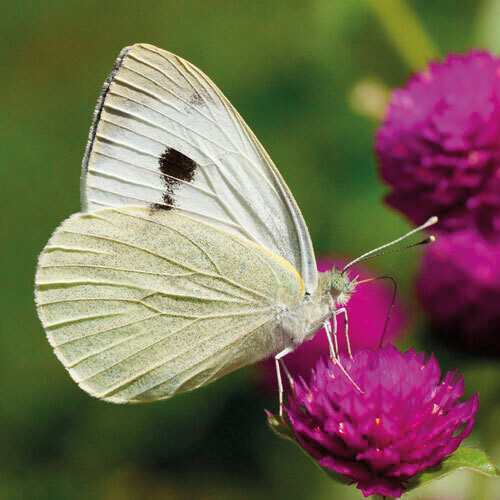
[376,51,500,237]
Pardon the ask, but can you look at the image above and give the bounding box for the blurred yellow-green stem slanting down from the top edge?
[366,0,439,71]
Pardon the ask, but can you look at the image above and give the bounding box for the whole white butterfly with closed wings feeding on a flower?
[35,44,436,403]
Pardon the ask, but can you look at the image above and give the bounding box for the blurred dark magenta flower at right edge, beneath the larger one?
[417,230,500,354]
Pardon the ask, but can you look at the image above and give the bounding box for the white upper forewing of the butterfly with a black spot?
[82,44,317,293]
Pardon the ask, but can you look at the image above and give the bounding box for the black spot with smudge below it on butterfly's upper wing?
[153,148,197,210]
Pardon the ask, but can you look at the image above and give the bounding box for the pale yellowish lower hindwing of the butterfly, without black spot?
[36,207,304,402]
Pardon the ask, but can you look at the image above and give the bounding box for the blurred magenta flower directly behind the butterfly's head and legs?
[257,257,409,392]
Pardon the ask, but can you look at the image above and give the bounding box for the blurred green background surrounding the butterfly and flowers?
[0,0,500,500]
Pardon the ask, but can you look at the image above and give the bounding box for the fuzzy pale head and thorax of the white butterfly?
[279,269,356,345]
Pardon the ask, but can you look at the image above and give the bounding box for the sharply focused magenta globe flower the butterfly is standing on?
[285,345,479,498]
